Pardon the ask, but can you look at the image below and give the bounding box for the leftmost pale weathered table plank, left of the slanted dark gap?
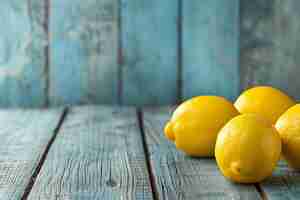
[0,110,62,200]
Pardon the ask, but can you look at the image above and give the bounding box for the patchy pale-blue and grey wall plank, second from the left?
[50,0,118,105]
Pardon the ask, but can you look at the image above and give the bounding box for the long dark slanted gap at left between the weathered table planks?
[21,107,69,200]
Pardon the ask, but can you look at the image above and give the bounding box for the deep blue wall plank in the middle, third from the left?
[121,0,178,106]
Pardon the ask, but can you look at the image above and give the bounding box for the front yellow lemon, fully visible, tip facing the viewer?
[215,114,281,183]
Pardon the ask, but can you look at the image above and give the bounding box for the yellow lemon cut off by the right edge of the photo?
[275,104,300,170]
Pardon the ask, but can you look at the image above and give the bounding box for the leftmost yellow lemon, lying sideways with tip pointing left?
[165,96,239,156]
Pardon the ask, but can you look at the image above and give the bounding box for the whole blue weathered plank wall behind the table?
[0,0,300,107]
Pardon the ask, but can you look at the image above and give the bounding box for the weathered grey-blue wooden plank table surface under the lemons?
[0,106,300,200]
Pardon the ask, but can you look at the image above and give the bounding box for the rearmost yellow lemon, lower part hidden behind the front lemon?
[234,86,295,124]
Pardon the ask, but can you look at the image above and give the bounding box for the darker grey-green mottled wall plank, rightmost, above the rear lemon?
[241,0,300,98]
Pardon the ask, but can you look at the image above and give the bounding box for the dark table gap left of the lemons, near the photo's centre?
[137,108,159,200]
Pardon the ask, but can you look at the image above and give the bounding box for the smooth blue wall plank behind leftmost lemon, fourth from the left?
[182,0,240,100]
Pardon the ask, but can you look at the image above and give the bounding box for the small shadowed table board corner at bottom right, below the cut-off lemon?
[261,161,300,200]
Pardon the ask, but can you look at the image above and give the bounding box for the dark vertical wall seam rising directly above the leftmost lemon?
[177,0,183,104]
